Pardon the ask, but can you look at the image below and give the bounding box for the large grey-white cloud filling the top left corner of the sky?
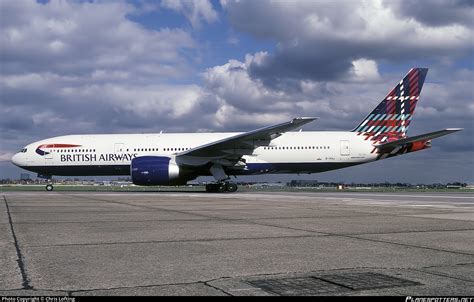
[0,0,196,80]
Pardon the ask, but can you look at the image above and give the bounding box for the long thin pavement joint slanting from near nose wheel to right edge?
[54,195,474,256]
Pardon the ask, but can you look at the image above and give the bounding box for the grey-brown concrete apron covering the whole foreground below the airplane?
[0,192,474,296]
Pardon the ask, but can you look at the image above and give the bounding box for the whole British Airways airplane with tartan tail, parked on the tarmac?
[11,68,462,193]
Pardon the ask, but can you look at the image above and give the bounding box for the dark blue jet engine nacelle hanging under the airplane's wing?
[130,156,181,186]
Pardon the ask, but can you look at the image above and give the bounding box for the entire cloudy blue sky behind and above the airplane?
[0,0,474,184]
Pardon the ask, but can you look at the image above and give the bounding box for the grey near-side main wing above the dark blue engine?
[176,117,317,166]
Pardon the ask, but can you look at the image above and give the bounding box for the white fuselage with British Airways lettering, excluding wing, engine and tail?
[12,131,376,176]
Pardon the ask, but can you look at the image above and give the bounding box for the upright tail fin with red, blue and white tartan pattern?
[352,68,428,143]
